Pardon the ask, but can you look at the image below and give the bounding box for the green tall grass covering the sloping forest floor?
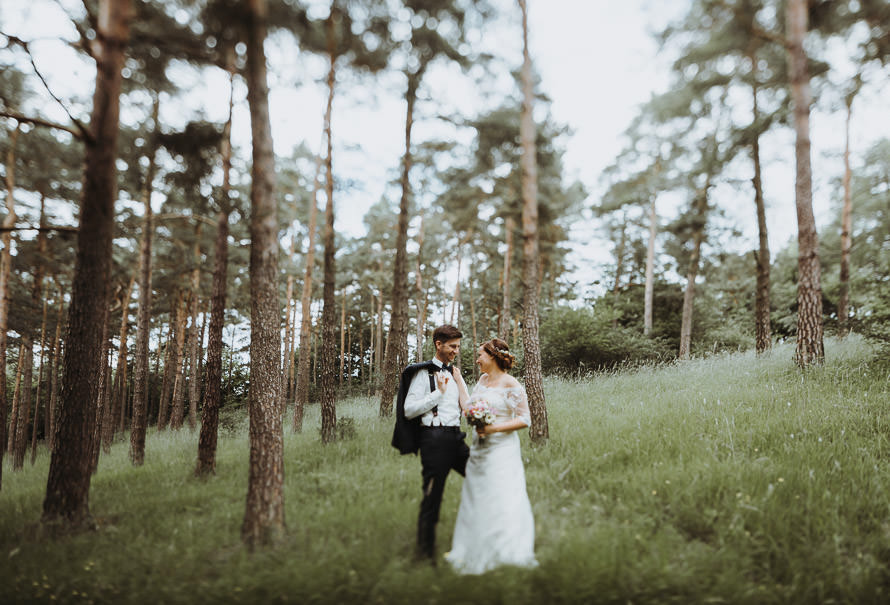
[0,338,890,603]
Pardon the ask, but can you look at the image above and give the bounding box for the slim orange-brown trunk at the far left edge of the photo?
[0,123,20,488]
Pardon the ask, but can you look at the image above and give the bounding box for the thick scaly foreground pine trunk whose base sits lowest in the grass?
[241,0,284,548]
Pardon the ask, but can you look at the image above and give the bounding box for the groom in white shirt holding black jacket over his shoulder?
[392,325,470,565]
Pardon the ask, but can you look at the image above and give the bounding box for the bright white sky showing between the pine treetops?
[0,0,890,300]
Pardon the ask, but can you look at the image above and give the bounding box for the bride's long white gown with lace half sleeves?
[445,374,538,574]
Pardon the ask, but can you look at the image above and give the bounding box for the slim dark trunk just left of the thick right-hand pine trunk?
[749,51,772,355]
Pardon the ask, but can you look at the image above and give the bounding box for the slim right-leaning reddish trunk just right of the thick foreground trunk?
[292,153,322,433]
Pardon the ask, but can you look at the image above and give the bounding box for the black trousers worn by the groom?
[417,426,470,561]
